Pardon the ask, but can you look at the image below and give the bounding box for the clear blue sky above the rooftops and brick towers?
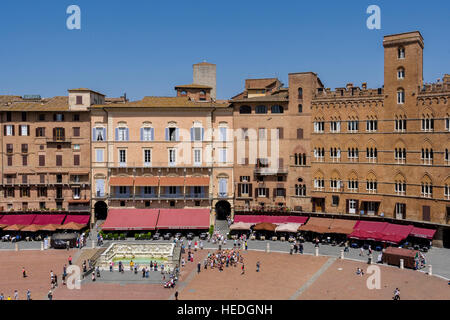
[0,0,450,99]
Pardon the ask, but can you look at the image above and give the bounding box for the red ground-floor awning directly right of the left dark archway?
[102,209,158,231]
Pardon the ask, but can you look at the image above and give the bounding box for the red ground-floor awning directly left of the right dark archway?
[156,209,210,229]
